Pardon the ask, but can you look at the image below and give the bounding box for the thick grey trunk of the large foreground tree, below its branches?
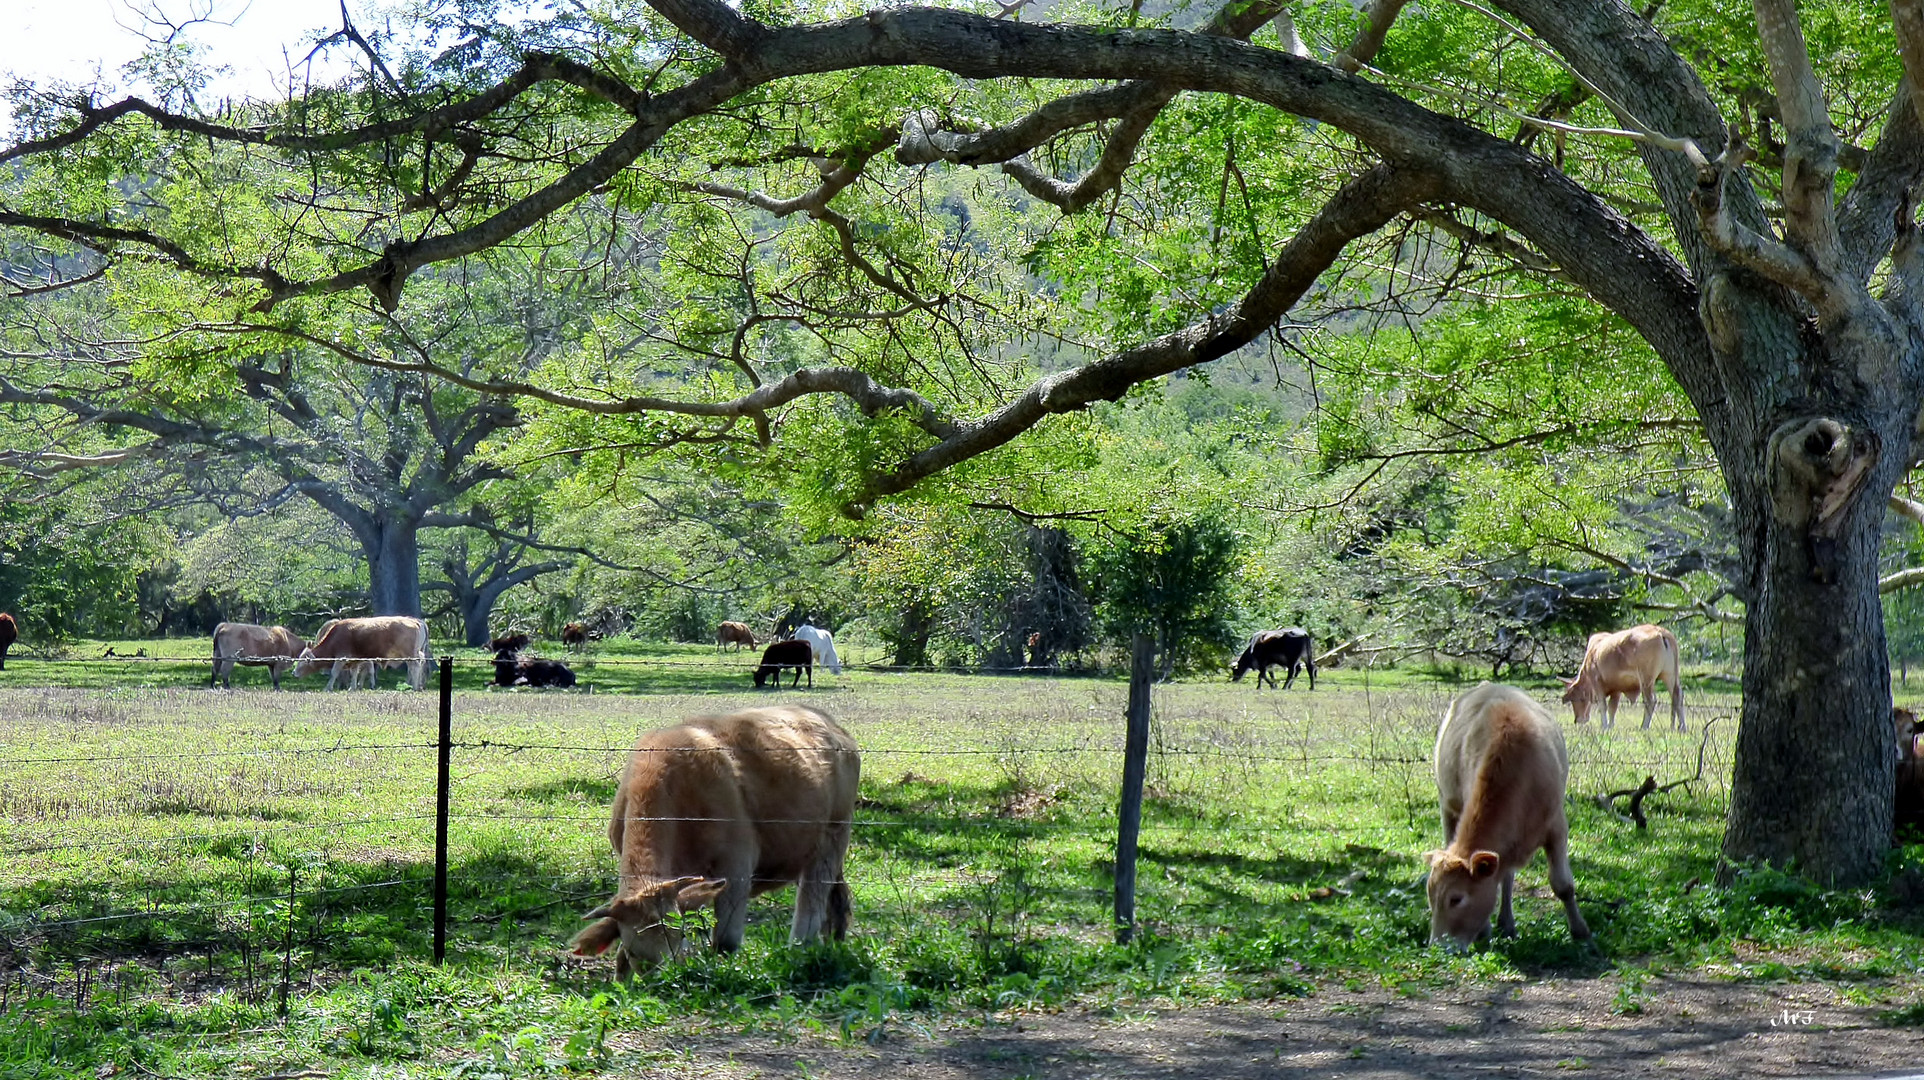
[1724,343,1911,886]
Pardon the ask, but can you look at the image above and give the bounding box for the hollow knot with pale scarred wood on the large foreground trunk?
[1766,416,1882,581]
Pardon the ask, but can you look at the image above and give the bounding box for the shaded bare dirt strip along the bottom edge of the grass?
[623,978,1924,1080]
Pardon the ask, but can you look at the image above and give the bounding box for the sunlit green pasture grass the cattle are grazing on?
[0,662,1924,1076]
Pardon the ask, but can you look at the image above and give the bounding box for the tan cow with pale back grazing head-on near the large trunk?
[1424,683,1589,947]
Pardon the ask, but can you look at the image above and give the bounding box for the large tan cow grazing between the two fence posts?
[571,707,862,978]
